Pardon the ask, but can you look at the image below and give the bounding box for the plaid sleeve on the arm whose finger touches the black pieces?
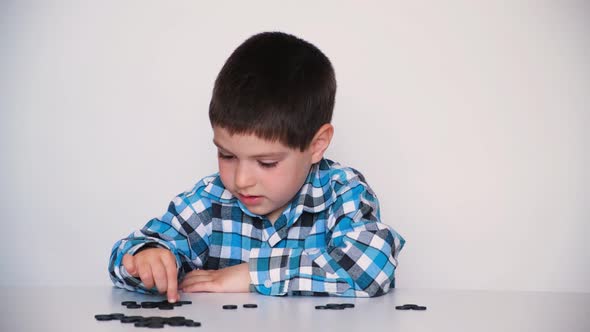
[108,193,210,294]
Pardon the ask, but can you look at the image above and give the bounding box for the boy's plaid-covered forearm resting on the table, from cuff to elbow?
[249,223,400,297]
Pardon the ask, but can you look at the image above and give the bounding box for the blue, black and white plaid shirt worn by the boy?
[109,159,405,297]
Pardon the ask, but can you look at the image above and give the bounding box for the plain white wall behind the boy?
[0,0,590,292]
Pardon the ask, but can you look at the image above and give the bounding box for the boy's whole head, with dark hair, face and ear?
[209,32,336,222]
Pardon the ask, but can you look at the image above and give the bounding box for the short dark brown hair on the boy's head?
[209,32,336,151]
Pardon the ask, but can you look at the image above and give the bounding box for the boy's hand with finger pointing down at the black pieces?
[123,248,180,303]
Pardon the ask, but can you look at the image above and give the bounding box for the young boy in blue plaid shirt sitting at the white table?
[109,32,405,302]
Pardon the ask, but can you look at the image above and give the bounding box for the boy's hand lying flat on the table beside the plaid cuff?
[180,263,251,293]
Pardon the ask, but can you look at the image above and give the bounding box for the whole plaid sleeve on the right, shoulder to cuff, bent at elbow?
[249,184,405,297]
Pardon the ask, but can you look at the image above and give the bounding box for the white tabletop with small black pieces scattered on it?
[0,287,590,332]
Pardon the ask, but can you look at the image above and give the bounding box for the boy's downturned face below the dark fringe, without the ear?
[213,126,318,223]
